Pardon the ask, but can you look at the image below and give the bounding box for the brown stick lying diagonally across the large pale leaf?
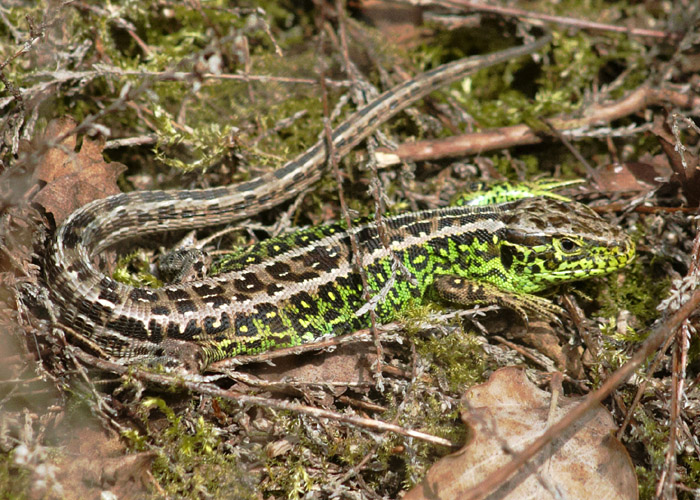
[465,289,700,500]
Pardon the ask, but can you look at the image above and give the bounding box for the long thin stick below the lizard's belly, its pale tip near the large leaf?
[69,347,454,448]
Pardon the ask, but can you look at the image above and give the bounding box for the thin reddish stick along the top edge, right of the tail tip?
[426,0,682,39]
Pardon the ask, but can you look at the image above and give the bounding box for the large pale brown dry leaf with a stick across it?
[404,368,638,500]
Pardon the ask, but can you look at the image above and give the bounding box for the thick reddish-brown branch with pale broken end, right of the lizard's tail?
[378,86,700,166]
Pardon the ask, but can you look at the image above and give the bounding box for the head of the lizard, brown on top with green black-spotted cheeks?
[500,198,635,293]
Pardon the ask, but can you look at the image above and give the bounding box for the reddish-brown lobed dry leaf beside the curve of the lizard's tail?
[34,118,126,224]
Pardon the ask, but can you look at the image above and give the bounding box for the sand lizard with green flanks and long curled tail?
[44,36,634,370]
